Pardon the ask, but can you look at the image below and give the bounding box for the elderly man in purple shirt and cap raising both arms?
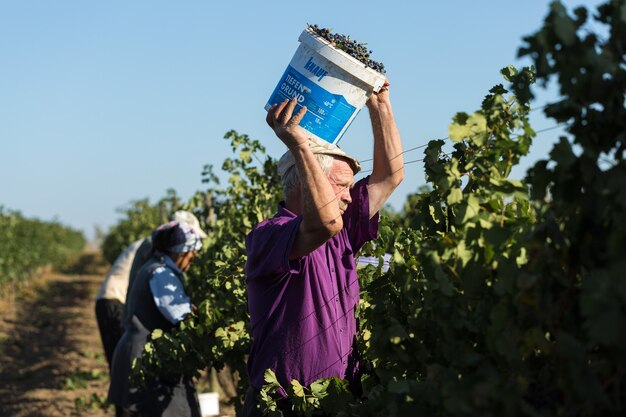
[244,84,404,416]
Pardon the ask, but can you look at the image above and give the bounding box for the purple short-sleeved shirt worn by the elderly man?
[246,177,378,389]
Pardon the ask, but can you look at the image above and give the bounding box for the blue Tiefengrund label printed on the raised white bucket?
[266,65,356,143]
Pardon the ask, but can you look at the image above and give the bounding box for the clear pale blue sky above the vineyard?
[0,0,598,237]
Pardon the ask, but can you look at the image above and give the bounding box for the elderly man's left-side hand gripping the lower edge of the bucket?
[265,98,308,149]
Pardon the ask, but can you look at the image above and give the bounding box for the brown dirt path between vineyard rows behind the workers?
[0,266,114,417]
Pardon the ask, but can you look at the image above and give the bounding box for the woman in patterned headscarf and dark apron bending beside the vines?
[108,221,202,417]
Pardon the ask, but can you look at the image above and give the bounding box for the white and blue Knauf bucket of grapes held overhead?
[265,29,385,144]
